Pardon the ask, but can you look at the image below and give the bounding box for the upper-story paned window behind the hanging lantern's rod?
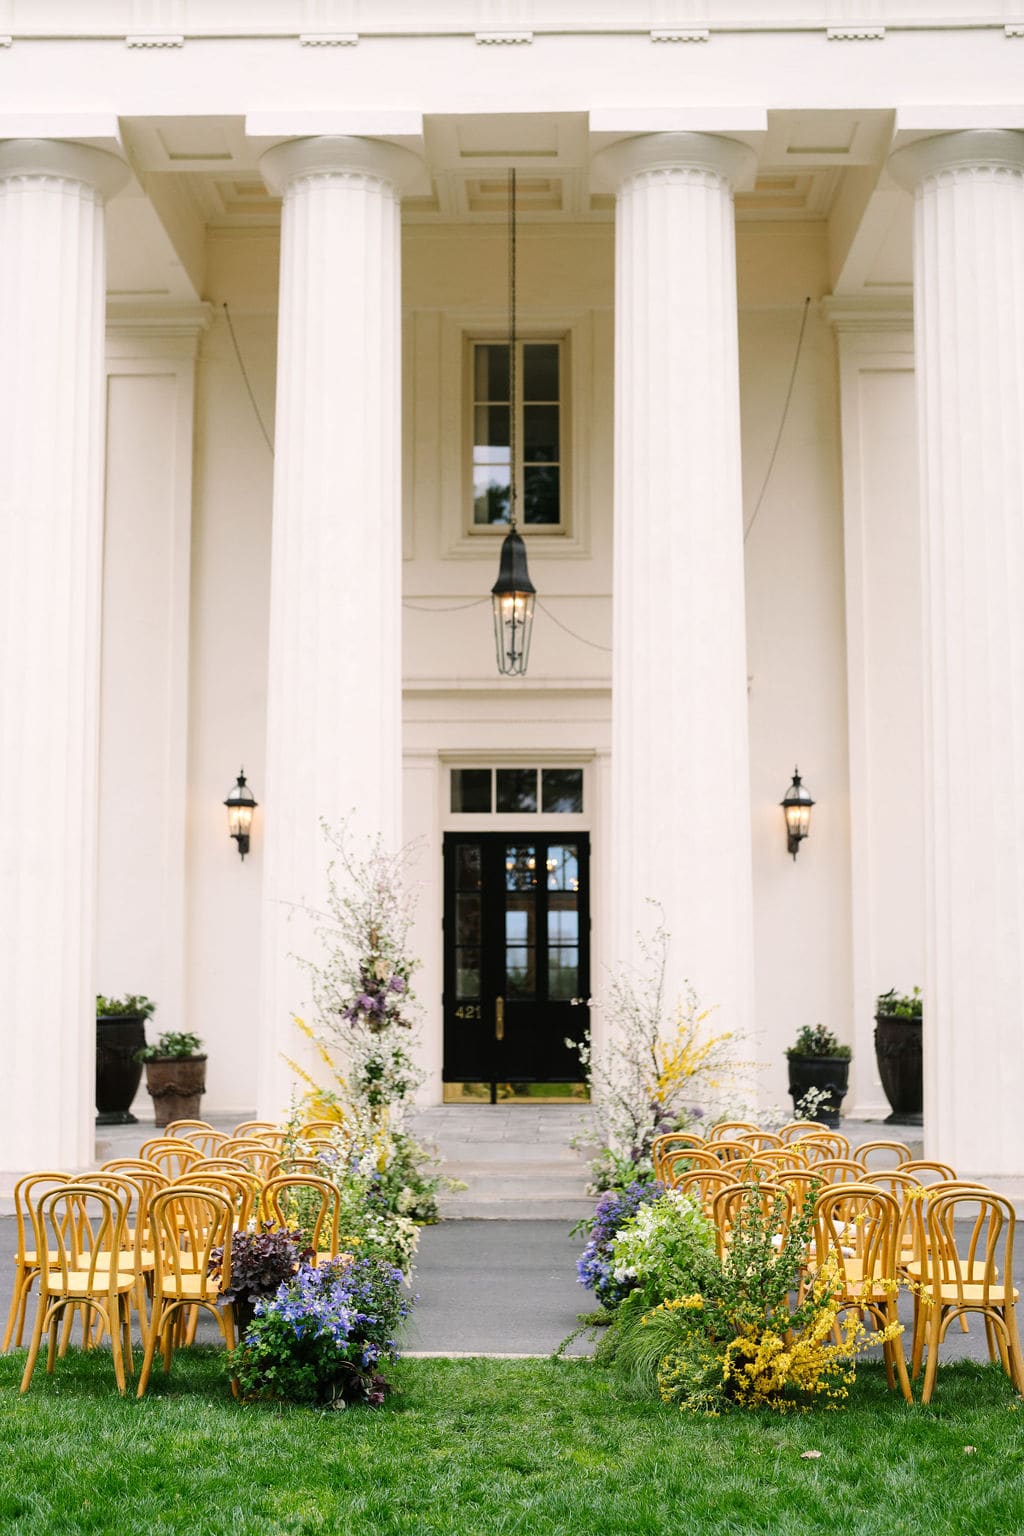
[471,339,567,531]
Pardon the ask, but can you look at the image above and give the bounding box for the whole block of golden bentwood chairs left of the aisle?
[3,1126,348,1396]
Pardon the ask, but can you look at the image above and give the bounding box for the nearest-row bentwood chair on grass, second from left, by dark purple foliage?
[138,1184,236,1398]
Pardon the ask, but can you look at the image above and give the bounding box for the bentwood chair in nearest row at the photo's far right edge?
[921,1187,1024,1402]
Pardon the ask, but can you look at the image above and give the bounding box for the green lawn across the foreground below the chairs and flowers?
[0,1349,1024,1536]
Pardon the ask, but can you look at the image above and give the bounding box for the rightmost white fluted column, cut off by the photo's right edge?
[890,132,1024,1175]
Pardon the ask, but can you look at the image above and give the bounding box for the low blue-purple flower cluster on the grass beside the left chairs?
[229,1255,411,1409]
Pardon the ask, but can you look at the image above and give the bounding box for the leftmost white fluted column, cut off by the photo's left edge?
[0,140,127,1178]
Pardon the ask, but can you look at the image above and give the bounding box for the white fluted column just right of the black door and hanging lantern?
[600,134,758,1031]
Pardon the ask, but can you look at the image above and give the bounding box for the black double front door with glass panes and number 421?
[444,833,590,1100]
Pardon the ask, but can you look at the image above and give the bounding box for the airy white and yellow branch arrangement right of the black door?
[567,903,752,1193]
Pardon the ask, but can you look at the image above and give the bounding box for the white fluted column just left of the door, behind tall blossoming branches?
[259,137,419,1115]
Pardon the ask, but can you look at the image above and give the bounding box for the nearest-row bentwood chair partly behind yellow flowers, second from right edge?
[811,1184,913,1402]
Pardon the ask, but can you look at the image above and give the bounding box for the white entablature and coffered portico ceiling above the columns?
[0,0,1024,303]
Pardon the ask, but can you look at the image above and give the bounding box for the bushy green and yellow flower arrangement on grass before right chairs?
[599,1186,901,1415]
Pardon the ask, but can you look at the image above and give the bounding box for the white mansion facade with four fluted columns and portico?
[0,0,1024,1175]
